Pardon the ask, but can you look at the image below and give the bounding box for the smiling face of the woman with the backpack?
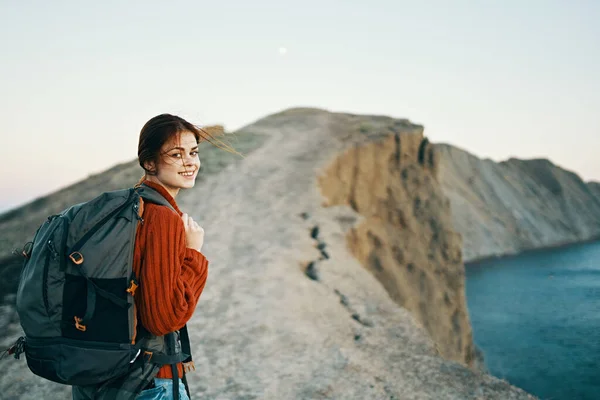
[148,131,200,197]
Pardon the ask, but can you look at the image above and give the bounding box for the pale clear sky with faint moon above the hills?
[0,0,600,211]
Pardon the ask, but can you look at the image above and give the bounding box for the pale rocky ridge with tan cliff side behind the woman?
[0,109,530,400]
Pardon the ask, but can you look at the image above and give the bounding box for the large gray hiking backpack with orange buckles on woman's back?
[5,185,191,396]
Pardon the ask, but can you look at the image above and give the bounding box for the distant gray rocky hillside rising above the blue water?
[435,144,600,261]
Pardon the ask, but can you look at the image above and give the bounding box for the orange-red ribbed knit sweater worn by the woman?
[133,180,208,378]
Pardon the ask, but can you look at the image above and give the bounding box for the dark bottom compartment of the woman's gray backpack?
[25,338,138,386]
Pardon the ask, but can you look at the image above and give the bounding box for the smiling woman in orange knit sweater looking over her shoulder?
[73,114,236,400]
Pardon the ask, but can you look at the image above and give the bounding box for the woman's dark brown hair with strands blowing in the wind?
[138,114,239,175]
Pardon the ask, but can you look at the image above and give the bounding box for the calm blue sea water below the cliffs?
[466,242,600,400]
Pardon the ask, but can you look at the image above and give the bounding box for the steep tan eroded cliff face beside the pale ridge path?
[319,130,474,365]
